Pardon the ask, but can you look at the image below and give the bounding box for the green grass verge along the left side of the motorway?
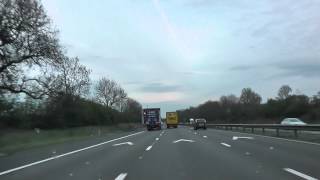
[0,123,140,156]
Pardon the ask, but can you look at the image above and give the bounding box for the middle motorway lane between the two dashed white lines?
[128,128,316,179]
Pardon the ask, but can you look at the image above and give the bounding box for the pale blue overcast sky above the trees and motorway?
[43,0,320,115]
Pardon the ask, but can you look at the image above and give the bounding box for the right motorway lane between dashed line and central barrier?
[200,129,320,178]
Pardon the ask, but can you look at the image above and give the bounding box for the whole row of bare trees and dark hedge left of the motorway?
[0,0,141,128]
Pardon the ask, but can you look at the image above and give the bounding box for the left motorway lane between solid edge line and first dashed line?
[0,131,160,180]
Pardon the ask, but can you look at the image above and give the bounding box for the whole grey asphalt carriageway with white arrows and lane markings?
[0,127,320,180]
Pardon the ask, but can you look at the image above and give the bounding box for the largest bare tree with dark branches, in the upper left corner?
[0,0,62,98]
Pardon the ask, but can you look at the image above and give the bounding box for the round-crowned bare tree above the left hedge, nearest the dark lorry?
[95,78,127,109]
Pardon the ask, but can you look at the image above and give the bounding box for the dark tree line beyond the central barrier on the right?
[178,85,320,124]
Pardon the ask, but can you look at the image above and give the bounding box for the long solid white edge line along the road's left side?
[0,131,145,176]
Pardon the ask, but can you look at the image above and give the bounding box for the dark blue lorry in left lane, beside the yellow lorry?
[142,108,161,131]
